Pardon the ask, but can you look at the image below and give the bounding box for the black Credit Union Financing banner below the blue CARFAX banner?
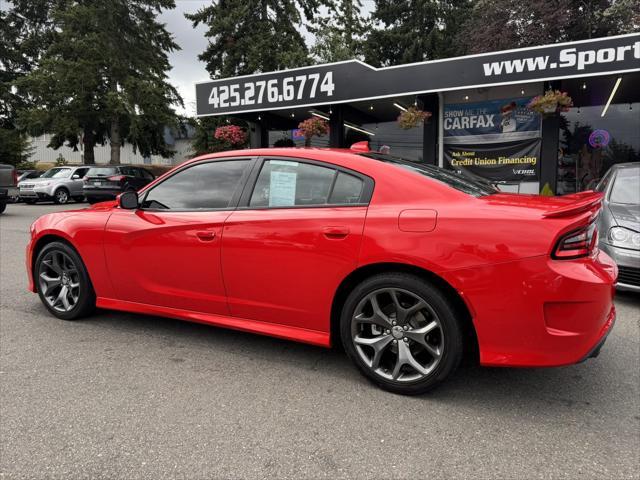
[444,139,541,182]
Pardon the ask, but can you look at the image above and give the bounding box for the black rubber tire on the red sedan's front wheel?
[33,242,96,320]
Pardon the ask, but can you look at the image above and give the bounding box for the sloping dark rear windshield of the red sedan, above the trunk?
[361,152,498,197]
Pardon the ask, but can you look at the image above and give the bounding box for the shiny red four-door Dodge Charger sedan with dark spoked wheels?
[26,149,617,394]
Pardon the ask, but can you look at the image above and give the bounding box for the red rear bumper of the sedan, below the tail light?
[445,248,617,367]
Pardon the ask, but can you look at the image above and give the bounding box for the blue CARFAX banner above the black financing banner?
[443,97,541,143]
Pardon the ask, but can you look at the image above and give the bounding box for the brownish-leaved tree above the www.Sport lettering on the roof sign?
[455,0,640,53]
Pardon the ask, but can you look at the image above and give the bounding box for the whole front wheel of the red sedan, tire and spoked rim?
[34,242,96,320]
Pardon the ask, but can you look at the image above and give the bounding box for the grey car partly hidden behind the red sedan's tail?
[596,162,640,292]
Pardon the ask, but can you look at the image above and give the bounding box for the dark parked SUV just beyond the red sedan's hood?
[83,165,155,203]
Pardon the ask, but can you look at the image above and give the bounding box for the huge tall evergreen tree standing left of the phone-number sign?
[19,0,182,164]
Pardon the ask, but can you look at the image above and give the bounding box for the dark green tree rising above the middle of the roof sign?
[364,0,469,66]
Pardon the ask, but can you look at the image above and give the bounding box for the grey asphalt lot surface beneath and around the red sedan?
[0,205,640,479]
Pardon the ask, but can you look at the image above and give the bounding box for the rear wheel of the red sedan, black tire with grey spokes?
[340,272,464,395]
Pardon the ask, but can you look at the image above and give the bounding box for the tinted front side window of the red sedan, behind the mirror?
[142,160,249,210]
